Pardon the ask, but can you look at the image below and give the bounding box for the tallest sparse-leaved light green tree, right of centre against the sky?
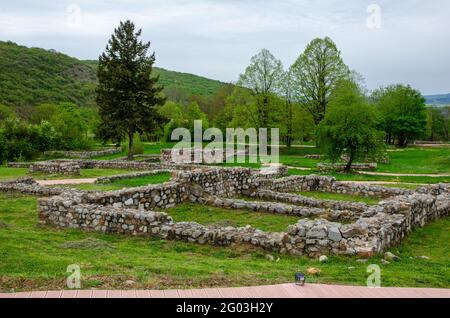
[291,37,350,124]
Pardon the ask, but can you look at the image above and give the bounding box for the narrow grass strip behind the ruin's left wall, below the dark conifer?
[67,173,170,191]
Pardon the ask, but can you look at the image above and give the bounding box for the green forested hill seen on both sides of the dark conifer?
[0,41,224,106]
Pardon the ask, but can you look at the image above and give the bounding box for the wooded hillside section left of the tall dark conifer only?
[0,41,96,106]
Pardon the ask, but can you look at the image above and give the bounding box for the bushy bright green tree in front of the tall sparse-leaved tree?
[317,81,384,171]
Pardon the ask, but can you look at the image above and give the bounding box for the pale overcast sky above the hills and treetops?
[0,0,450,94]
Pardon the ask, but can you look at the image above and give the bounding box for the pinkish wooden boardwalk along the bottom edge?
[0,284,450,298]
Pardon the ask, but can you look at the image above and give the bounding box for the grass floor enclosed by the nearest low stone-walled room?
[167,204,300,232]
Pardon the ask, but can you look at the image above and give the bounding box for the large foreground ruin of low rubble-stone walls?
[0,166,450,257]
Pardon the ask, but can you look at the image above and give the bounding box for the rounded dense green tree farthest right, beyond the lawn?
[372,85,427,147]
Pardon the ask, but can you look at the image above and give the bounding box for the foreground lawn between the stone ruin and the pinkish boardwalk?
[0,194,450,291]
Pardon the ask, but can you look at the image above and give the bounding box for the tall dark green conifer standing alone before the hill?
[97,20,165,160]
